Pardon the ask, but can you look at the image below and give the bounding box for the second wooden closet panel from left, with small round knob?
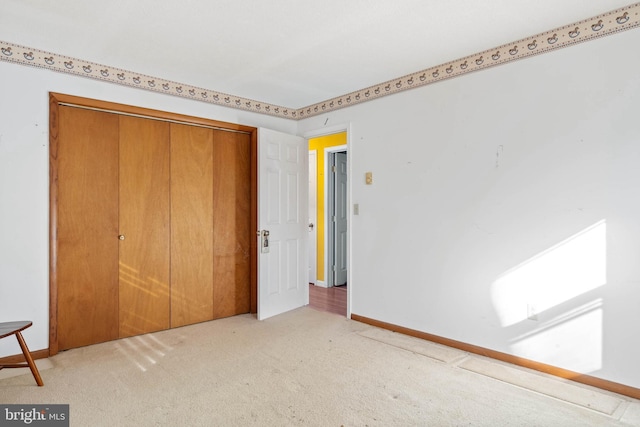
[119,116,170,337]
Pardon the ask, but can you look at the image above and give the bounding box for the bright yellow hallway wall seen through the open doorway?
[309,132,347,281]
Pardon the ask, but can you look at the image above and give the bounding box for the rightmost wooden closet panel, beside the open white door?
[213,130,249,319]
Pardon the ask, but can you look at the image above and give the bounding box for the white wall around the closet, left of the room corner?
[0,62,296,357]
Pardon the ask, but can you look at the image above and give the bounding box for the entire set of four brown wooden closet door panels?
[52,98,253,351]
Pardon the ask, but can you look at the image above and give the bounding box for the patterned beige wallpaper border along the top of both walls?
[0,3,640,120]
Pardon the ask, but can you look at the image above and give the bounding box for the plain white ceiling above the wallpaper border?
[0,0,632,108]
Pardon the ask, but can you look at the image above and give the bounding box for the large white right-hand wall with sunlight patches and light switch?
[298,30,640,387]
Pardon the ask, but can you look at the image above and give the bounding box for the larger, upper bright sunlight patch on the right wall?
[491,220,607,327]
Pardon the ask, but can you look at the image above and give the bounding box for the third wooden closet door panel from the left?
[171,124,214,327]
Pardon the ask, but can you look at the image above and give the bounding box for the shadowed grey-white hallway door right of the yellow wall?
[333,152,348,286]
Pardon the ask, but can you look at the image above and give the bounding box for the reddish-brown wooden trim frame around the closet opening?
[49,92,258,356]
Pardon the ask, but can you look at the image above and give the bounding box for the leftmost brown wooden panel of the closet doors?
[52,106,118,350]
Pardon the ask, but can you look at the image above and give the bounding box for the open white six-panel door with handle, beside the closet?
[258,128,309,320]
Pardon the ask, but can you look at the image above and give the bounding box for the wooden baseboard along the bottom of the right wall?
[351,314,640,399]
